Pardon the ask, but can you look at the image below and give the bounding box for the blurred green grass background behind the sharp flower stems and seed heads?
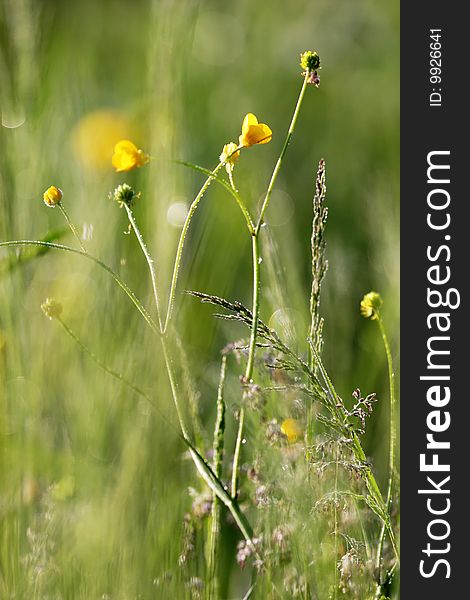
[0,0,399,599]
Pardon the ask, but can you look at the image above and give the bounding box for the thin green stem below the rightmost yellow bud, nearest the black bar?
[376,314,397,580]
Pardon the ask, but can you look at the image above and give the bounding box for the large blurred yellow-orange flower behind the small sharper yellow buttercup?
[72,108,138,171]
